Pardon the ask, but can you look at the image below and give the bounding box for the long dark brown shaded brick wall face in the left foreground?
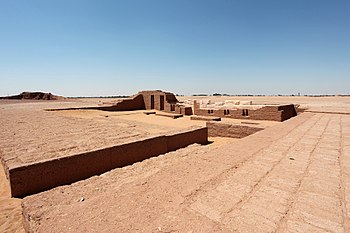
[6,127,208,197]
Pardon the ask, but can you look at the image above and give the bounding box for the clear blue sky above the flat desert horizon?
[0,0,350,96]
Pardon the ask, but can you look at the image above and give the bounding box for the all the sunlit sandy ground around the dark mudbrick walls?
[0,97,350,232]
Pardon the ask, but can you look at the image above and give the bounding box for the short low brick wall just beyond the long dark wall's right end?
[206,121,263,138]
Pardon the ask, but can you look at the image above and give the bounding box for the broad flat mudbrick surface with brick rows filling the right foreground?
[23,113,350,232]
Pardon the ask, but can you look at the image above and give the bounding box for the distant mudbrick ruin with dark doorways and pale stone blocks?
[89,90,297,122]
